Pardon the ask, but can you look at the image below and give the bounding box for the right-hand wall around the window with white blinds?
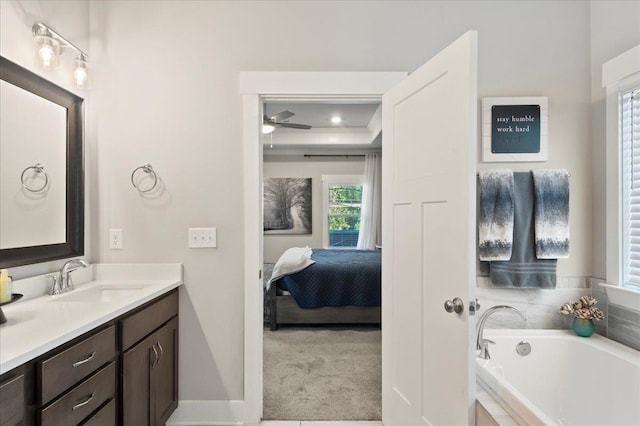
[590,1,640,279]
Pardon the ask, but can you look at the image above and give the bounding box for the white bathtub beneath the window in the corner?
[476,329,640,426]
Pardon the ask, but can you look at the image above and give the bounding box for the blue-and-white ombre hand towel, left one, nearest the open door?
[478,169,513,261]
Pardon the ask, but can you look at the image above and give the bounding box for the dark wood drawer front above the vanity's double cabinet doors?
[121,291,178,351]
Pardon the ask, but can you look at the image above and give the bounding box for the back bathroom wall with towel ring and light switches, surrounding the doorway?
[91,1,592,400]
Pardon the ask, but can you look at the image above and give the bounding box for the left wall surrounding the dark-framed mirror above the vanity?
[0,0,94,279]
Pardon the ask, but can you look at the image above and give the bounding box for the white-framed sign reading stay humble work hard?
[482,96,549,163]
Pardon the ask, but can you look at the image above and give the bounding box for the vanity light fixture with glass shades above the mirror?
[31,22,89,89]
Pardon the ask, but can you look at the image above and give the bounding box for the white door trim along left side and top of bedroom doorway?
[240,72,407,424]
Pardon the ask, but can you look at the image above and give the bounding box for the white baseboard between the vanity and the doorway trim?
[167,401,244,426]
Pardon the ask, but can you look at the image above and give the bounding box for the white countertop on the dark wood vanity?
[0,264,182,374]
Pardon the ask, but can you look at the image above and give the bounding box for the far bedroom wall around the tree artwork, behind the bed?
[263,156,364,263]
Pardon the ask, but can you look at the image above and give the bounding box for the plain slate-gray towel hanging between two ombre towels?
[489,172,558,288]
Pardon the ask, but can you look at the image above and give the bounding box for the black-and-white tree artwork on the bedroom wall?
[264,178,312,234]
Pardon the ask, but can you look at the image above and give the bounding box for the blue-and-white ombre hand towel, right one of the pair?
[533,169,569,259]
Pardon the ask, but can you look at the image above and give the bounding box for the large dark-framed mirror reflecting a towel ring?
[0,57,84,268]
